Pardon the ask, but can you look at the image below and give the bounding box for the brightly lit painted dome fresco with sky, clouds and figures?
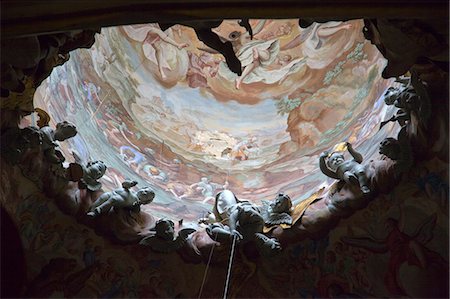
[33,20,395,221]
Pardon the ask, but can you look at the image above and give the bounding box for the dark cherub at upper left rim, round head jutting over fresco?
[40,121,77,163]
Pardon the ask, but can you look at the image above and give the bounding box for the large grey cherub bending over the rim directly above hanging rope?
[206,190,281,256]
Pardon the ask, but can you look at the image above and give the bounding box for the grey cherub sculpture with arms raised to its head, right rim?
[319,142,370,193]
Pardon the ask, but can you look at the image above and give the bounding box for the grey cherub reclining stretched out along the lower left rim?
[87,181,155,217]
